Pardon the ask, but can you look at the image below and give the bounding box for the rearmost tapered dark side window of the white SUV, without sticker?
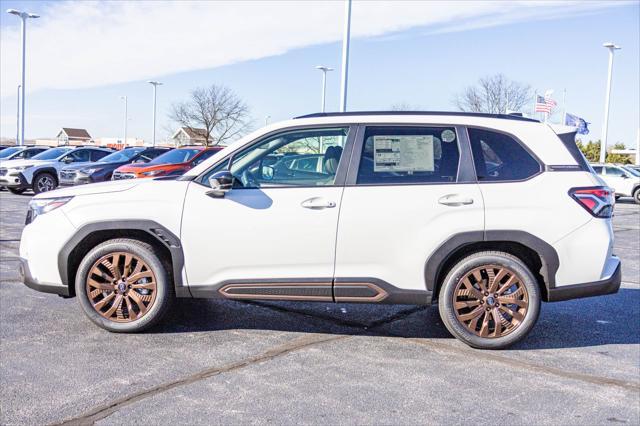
[468,129,540,182]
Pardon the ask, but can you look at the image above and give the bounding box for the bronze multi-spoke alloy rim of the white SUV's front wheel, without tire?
[86,252,157,322]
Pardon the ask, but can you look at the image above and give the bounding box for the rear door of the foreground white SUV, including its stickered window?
[334,125,484,303]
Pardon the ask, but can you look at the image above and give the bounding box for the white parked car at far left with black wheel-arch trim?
[0,146,113,194]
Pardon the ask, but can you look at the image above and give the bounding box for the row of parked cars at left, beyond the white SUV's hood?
[0,146,222,194]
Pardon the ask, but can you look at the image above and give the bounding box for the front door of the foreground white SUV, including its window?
[181,126,353,301]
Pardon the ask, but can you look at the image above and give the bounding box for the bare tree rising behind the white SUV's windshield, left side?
[169,84,249,145]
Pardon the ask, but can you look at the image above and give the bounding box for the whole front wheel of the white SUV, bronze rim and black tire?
[75,239,174,333]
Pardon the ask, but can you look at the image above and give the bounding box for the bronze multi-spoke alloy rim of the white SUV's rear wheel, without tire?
[453,265,529,338]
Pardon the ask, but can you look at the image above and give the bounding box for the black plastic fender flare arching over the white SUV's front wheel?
[58,220,191,297]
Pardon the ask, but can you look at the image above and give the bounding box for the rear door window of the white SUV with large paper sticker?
[357,126,460,185]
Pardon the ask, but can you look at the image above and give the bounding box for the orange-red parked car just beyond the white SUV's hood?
[111,146,224,180]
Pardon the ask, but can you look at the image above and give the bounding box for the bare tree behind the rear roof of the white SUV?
[454,74,532,114]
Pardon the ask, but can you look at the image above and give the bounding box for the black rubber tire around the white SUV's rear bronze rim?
[438,251,541,349]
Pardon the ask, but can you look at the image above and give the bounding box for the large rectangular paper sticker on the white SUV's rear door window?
[373,135,434,172]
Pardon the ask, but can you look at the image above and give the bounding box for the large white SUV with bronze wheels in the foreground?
[20,112,620,348]
